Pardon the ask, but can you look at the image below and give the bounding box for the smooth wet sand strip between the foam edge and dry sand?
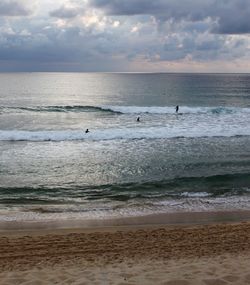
[0,210,250,233]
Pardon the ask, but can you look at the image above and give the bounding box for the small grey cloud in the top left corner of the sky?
[0,0,31,16]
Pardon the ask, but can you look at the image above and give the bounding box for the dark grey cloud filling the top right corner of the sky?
[90,0,250,34]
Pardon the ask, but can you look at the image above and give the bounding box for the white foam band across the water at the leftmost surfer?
[0,124,250,141]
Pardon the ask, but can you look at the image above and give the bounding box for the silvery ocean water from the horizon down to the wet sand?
[0,73,250,221]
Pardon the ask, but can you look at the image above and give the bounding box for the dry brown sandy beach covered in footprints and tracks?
[0,214,250,285]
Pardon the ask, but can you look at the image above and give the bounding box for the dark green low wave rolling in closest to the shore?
[0,173,250,204]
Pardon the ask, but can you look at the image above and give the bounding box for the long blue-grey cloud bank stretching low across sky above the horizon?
[0,14,246,71]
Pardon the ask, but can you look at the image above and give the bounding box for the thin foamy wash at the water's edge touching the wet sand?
[0,195,250,222]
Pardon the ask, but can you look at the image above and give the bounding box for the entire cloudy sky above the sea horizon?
[0,0,250,72]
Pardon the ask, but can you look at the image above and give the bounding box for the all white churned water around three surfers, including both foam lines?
[0,106,250,141]
